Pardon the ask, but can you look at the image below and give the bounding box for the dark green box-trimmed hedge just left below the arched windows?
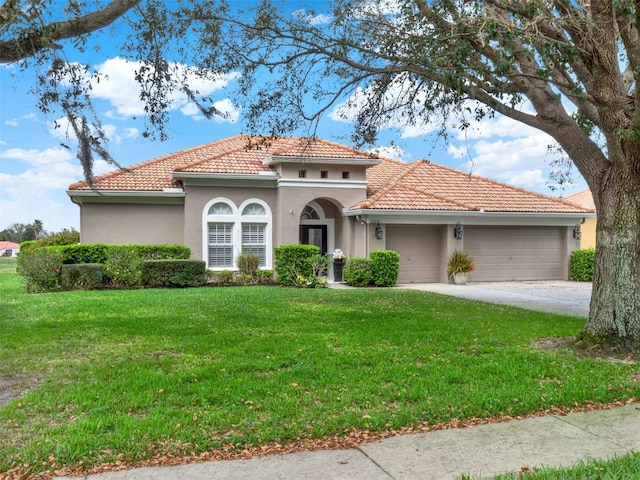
[140,259,206,288]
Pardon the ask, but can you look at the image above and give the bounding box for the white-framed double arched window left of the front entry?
[202,198,272,270]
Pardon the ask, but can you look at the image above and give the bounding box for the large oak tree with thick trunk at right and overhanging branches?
[0,0,640,342]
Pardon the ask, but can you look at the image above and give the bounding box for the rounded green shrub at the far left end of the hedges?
[19,248,62,293]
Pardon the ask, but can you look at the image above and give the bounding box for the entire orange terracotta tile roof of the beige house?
[69,135,593,213]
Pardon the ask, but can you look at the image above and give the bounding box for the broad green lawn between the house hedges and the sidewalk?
[0,274,640,473]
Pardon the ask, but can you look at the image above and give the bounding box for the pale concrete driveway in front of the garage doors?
[398,281,591,317]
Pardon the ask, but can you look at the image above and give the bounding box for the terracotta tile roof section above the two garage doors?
[351,159,587,213]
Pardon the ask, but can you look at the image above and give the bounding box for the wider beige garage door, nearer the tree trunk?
[464,226,565,281]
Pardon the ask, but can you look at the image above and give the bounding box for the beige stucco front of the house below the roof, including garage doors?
[70,143,595,283]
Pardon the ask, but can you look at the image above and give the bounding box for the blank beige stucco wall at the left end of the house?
[80,203,184,245]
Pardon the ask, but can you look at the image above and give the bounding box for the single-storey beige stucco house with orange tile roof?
[68,135,595,283]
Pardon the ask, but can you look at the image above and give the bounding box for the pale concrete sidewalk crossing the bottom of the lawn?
[57,403,640,480]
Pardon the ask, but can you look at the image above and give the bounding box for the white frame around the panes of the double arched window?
[202,197,273,270]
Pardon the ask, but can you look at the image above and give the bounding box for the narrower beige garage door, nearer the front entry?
[386,225,441,283]
